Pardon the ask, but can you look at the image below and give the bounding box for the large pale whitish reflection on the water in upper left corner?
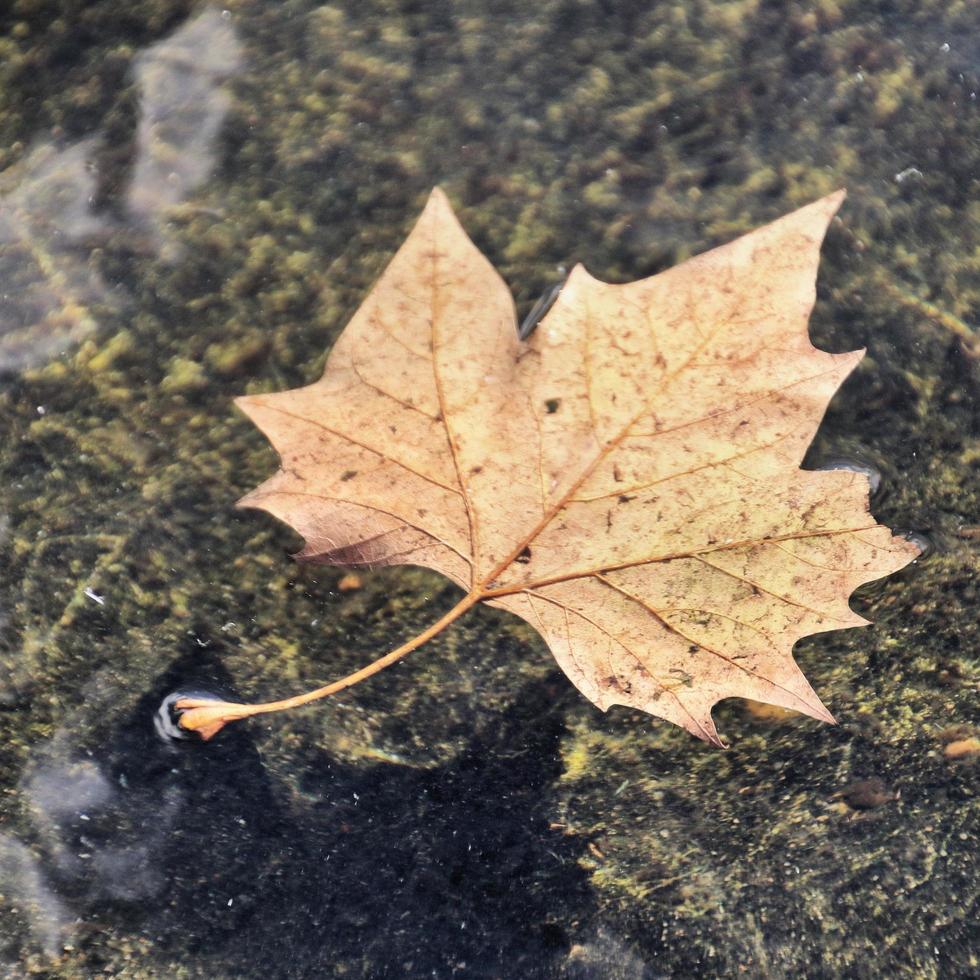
[0,7,242,375]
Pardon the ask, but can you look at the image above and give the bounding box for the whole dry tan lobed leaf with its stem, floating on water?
[177,190,918,744]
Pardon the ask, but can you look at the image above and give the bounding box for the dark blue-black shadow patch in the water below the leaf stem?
[30,650,591,978]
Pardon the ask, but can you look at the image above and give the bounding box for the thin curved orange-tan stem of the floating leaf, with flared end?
[173,591,483,741]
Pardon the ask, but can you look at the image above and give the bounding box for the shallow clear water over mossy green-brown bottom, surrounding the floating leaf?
[0,0,980,978]
